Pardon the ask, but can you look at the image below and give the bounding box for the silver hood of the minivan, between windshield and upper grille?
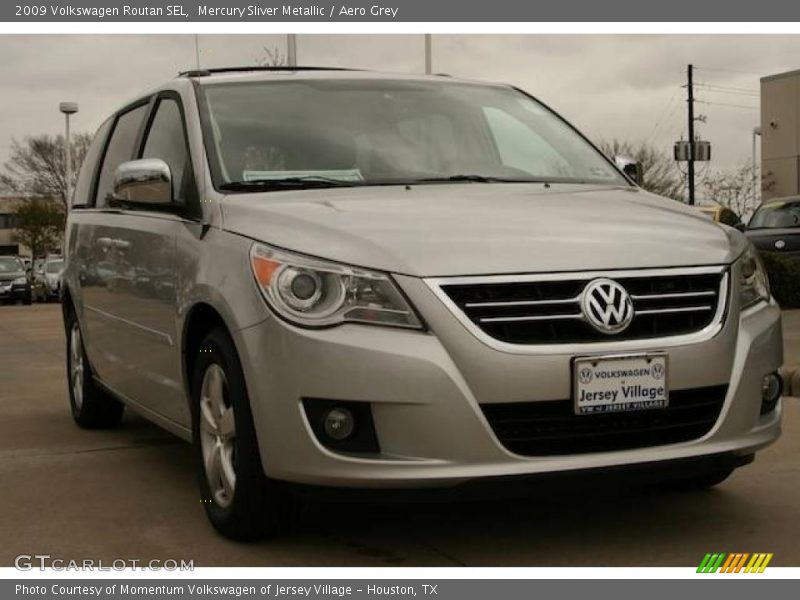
[221,183,746,277]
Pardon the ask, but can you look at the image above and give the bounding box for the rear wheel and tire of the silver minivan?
[66,310,125,429]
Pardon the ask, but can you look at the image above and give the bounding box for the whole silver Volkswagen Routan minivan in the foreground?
[63,69,782,539]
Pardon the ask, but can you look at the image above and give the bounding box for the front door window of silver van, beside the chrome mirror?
[142,98,194,200]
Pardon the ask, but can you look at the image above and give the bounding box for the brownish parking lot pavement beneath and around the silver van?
[0,305,800,566]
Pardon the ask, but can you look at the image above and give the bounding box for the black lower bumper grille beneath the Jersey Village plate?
[481,385,728,456]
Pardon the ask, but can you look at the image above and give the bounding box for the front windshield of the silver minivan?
[203,79,628,191]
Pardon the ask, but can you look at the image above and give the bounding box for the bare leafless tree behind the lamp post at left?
[0,133,92,209]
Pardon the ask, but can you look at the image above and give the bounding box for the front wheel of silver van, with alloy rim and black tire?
[191,328,297,541]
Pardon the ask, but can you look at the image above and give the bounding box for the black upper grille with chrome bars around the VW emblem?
[440,268,727,344]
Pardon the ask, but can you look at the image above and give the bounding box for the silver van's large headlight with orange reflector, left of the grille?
[250,244,422,329]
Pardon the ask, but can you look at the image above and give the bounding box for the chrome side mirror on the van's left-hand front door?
[113,158,173,208]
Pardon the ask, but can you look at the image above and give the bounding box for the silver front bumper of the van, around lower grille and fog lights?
[234,277,782,488]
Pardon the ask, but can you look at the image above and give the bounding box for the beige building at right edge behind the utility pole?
[761,70,800,200]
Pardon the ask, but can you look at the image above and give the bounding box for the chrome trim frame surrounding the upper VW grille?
[423,265,730,354]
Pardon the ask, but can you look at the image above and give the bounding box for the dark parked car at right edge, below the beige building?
[746,196,800,260]
